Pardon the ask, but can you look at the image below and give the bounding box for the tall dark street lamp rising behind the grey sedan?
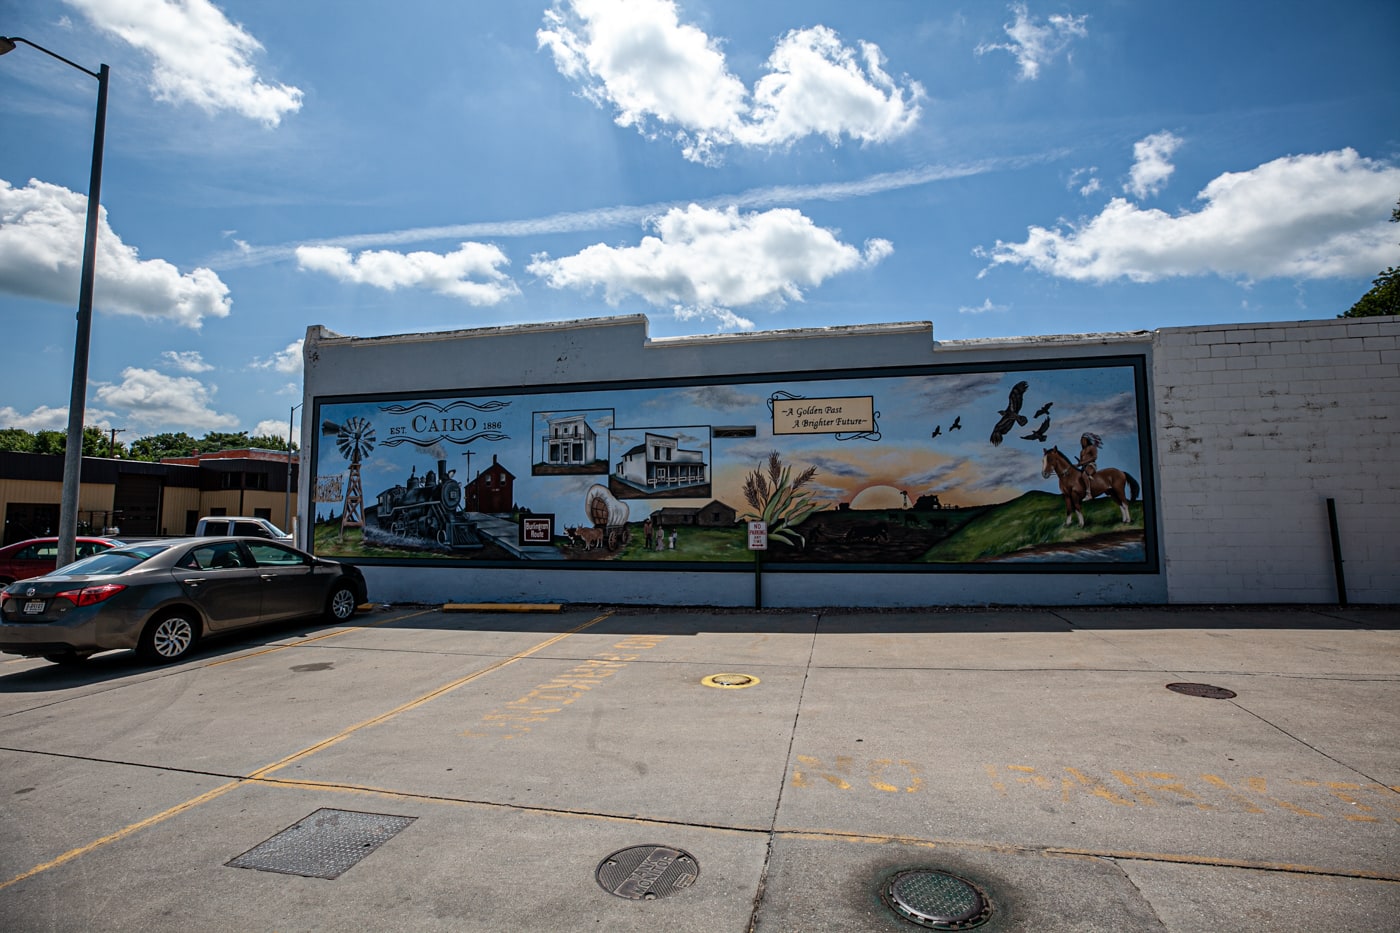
[0,35,108,567]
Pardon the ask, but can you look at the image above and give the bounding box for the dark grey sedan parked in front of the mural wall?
[0,537,368,664]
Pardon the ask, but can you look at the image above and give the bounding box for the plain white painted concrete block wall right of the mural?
[1152,317,1400,604]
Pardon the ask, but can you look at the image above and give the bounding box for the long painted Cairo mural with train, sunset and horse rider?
[309,357,1156,572]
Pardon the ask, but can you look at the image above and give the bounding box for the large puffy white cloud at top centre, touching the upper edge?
[536,0,924,163]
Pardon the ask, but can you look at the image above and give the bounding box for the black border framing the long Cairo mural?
[309,347,1162,576]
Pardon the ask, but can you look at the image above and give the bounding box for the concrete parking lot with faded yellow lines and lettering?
[0,607,1400,933]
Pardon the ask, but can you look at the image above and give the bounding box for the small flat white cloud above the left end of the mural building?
[297,242,519,305]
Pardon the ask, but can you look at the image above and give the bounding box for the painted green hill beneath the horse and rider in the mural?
[920,490,1142,563]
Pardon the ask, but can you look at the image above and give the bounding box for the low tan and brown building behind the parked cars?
[0,450,297,544]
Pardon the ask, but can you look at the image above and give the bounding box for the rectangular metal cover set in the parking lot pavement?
[227,807,417,878]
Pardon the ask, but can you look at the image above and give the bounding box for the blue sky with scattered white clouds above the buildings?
[0,0,1400,443]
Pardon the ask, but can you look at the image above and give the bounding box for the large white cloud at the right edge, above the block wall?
[977,148,1400,282]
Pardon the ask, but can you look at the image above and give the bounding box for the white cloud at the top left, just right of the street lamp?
[67,0,301,126]
